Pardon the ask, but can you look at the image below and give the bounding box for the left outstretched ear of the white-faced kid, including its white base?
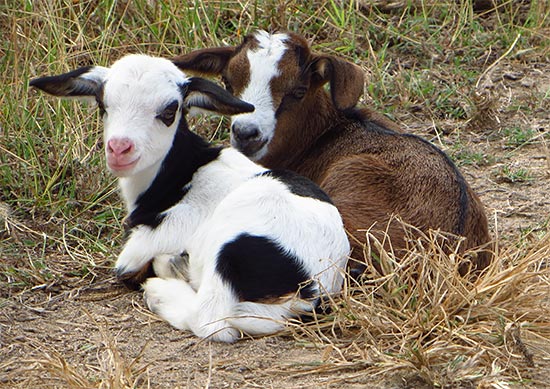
[29,66,109,99]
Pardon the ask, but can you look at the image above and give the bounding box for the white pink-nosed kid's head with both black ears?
[30,55,254,177]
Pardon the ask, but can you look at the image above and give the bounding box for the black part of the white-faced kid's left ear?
[29,66,99,96]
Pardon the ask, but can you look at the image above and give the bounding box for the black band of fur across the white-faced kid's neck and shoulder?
[126,123,221,228]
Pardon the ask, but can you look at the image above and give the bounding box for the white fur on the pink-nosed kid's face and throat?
[97,55,190,212]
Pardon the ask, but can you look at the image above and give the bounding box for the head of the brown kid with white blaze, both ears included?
[174,31,364,161]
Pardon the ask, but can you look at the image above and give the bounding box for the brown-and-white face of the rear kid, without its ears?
[223,31,309,160]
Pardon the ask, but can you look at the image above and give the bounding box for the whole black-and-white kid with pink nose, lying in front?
[30,54,349,342]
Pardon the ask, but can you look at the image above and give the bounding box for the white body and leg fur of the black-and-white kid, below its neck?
[135,149,349,341]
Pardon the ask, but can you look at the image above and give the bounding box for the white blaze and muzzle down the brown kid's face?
[231,31,288,160]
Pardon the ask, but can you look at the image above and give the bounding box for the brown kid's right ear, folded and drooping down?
[311,55,365,109]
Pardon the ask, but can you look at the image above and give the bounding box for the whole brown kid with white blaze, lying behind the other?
[173,31,492,275]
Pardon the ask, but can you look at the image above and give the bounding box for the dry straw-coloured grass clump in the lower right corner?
[291,223,550,387]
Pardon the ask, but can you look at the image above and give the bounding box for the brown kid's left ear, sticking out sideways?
[172,47,235,76]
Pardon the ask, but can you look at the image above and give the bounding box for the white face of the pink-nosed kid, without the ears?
[99,56,189,177]
